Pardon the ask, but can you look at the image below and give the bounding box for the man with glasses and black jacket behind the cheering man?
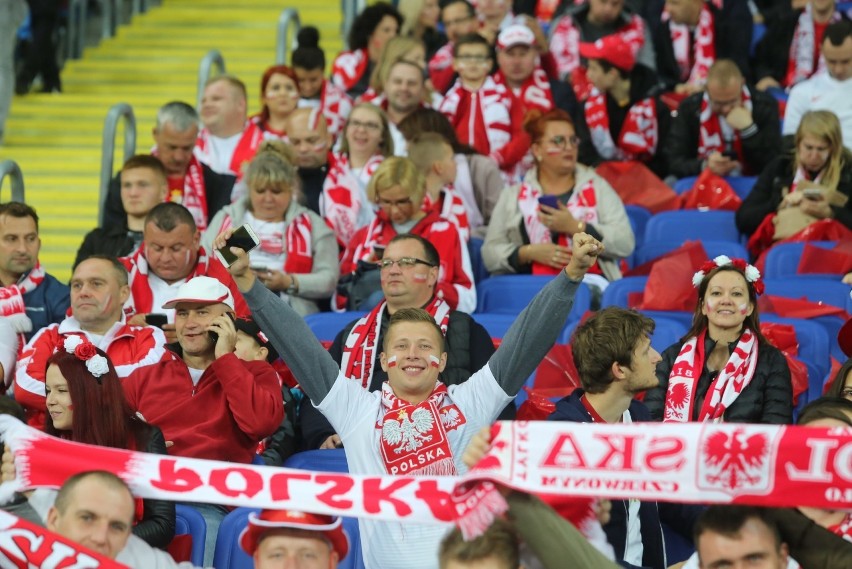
[299,233,502,450]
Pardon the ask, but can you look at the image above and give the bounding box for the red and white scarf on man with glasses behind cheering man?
[340,296,451,389]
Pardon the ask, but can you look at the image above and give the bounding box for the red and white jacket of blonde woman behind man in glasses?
[340,209,476,313]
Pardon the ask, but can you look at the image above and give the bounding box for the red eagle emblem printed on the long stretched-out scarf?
[702,429,769,491]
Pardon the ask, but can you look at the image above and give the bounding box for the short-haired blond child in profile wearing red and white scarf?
[408,132,470,241]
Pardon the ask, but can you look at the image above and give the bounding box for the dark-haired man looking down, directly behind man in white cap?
[122,203,249,343]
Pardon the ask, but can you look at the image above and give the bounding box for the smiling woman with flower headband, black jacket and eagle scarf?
[645,255,793,424]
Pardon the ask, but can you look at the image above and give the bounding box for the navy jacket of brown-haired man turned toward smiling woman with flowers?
[548,388,704,569]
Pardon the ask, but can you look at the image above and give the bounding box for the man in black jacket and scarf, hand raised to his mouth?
[665,59,781,178]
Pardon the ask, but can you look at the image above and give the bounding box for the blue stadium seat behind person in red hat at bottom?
[213,508,364,569]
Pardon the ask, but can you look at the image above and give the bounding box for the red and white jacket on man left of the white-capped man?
[15,316,167,429]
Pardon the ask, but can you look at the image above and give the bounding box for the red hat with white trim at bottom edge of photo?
[240,510,349,561]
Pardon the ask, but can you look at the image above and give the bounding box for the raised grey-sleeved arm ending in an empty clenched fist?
[488,233,604,396]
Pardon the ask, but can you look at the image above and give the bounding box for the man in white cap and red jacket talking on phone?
[123,276,284,566]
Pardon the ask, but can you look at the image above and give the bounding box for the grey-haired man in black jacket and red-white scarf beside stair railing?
[103,101,236,231]
